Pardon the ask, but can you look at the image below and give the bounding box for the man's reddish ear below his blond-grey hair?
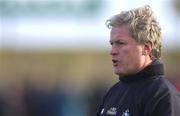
[142,41,153,56]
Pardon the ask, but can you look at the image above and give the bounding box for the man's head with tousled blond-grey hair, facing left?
[106,6,161,76]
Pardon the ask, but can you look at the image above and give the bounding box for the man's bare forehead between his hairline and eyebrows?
[111,25,132,40]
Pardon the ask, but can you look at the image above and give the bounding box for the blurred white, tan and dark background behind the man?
[0,0,180,116]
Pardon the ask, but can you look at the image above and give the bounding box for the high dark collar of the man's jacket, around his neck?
[119,59,164,82]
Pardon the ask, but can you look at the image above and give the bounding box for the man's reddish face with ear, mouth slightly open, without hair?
[110,25,152,77]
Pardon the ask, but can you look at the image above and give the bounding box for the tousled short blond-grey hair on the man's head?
[106,5,162,58]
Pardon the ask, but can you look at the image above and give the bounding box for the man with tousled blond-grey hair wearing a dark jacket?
[97,5,180,116]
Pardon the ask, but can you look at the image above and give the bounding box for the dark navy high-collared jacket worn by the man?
[97,60,180,116]
